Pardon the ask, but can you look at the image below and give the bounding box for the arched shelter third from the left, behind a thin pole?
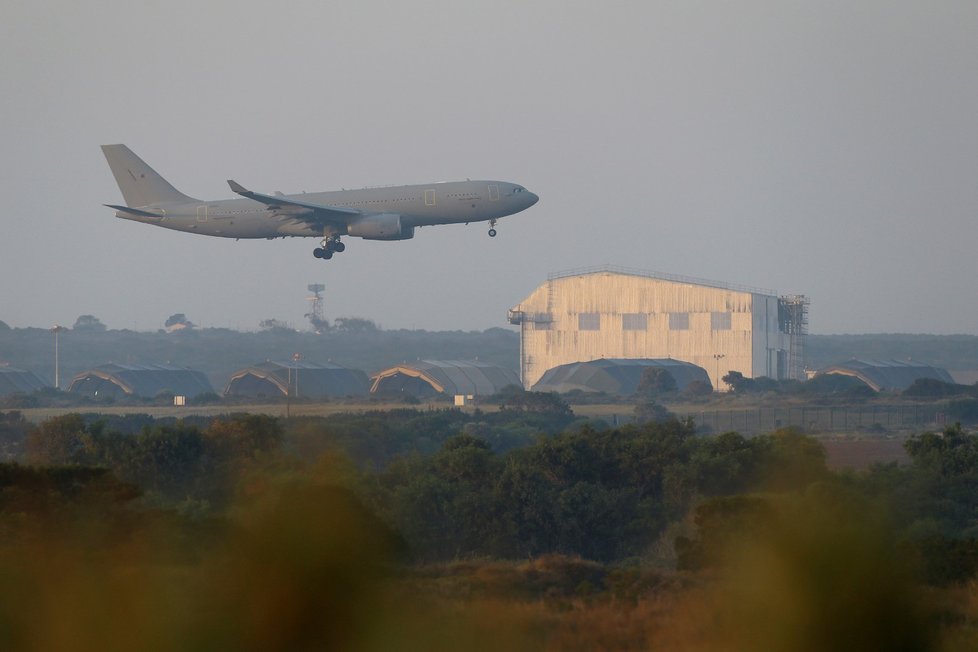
[224,361,370,398]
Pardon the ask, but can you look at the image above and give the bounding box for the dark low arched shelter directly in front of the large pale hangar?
[533,358,712,396]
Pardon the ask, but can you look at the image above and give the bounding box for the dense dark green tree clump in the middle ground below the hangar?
[366,420,827,561]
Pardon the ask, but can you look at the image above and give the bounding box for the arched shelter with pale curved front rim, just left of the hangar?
[370,360,520,396]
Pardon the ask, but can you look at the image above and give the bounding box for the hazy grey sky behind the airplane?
[0,0,978,334]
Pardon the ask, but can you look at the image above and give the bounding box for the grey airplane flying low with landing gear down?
[102,145,539,260]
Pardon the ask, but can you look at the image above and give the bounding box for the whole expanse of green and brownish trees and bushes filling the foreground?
[9,410,978,650]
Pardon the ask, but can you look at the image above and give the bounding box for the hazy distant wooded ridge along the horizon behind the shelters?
[0,318,978,389]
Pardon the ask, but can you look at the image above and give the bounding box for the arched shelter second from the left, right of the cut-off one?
[68,363,214,398]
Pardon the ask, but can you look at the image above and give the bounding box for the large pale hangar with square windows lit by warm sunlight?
[509,265,809,390]
